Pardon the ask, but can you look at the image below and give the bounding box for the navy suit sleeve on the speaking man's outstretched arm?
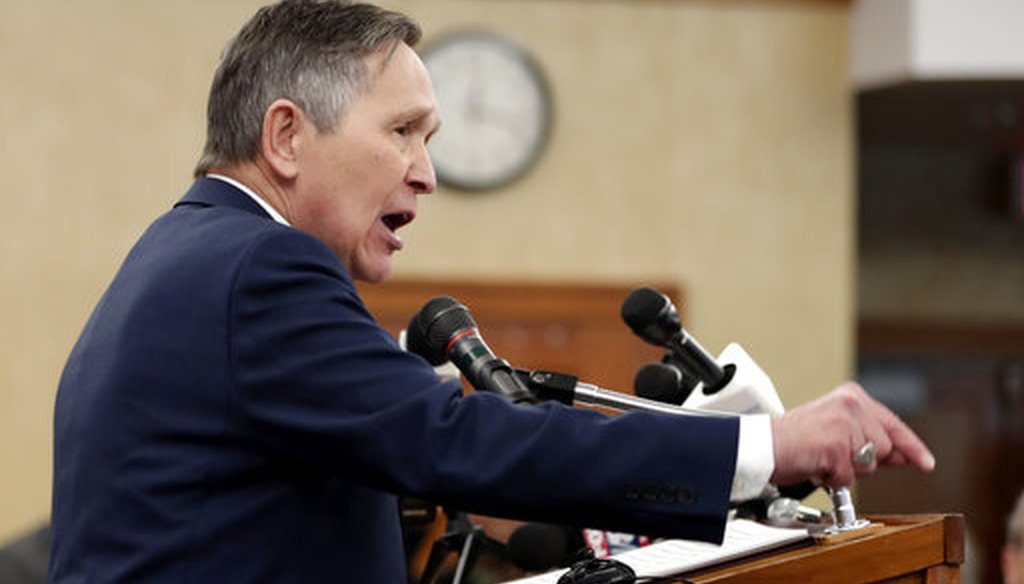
[227,232,738,541]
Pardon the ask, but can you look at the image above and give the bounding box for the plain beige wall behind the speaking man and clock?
[0,0,854,540]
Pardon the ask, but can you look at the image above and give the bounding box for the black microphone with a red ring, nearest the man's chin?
[406,296,534,404]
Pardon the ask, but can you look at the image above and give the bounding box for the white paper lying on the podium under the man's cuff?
[501,519,810,584]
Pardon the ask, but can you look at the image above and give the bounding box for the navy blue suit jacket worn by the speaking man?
[50,178,738,584]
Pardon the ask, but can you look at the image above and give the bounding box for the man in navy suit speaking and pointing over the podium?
[49,0,934,584]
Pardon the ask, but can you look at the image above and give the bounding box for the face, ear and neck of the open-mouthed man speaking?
[290,43,438,282]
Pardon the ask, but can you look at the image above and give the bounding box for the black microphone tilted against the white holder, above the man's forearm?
[622,286,731,394]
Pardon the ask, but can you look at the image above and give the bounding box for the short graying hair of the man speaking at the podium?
[195,0,422,176]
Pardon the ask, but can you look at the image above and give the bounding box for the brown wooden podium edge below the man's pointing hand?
[673,515,964,584]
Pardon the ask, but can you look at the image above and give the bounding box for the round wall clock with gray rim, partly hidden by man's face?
[422,32,551,191]
